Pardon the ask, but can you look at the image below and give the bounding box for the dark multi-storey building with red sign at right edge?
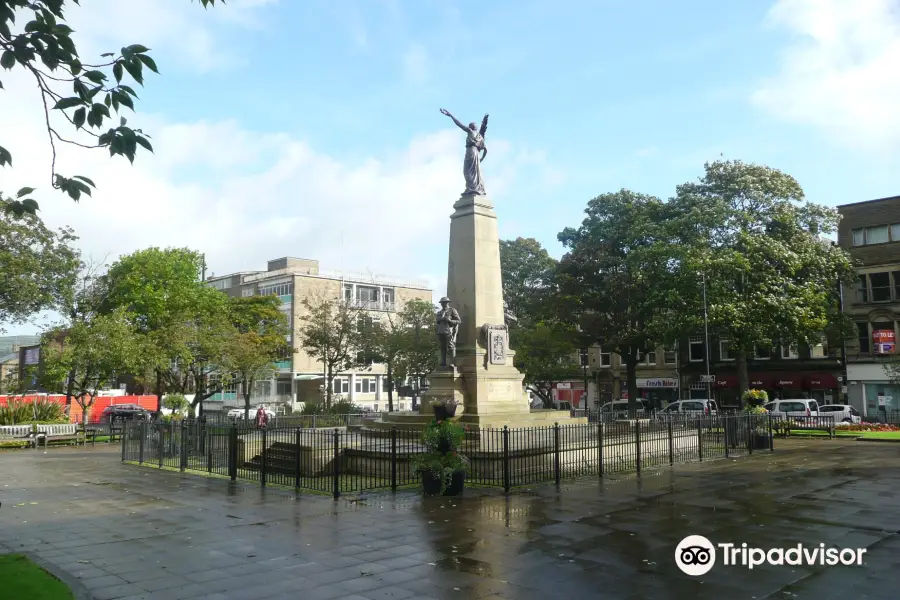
[838,196,900,416]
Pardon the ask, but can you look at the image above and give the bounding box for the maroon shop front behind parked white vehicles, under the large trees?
[713,371,840,408]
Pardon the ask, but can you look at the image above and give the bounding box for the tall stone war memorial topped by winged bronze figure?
[421,109,569,427]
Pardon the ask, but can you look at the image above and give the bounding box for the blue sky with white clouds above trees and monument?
[0,0,900,331]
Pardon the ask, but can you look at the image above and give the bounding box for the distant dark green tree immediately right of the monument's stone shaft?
[500,237,557,327]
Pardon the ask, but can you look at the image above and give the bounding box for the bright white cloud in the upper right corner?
[752,0,900,153]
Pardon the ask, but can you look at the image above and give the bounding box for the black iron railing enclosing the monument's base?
[122,414,777,497]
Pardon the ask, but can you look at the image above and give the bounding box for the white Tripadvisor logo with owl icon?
[675,535,866,577]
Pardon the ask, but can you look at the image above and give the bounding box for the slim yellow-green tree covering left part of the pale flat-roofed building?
[226,296,290,419]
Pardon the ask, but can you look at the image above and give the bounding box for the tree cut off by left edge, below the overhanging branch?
[0,194,79,331]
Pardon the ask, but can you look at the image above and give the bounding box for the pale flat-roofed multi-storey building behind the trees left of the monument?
[205,258,432,411]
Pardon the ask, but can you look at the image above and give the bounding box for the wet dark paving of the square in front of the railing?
[0,440,900,600]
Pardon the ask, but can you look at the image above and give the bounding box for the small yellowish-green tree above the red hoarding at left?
[41,310,141,423]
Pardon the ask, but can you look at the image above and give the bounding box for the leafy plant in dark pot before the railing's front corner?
[412,418,469,496]
